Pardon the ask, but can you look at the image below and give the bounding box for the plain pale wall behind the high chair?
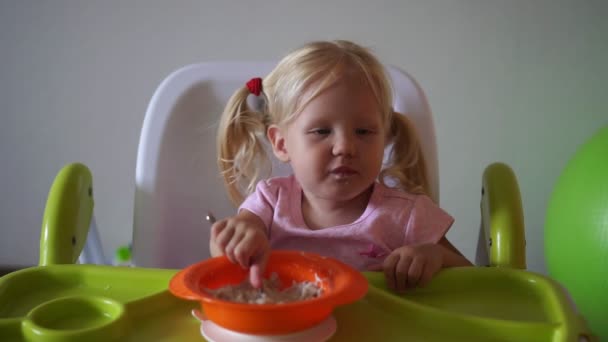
[0,0,608,272]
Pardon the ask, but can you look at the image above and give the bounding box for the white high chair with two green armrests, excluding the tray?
[40,62,525,268]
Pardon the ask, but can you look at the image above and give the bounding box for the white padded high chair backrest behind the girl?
[132,63,439,268]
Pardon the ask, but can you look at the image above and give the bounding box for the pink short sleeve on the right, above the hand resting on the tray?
[405,195,454,245]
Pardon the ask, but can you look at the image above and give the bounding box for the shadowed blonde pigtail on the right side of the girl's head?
[380,112,430,194]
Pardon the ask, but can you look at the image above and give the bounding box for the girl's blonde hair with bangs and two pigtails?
[217,40,429,205]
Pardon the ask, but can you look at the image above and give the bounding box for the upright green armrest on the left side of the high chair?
[39,163,93,266]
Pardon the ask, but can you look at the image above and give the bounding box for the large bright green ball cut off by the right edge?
[545,126,608,341]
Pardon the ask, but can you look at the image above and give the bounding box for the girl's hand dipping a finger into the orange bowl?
[211,212,270,288]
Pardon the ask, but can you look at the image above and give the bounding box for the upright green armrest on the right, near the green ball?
[481,163,526,269]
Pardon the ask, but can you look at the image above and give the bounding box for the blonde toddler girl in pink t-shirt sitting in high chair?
[210,41,471,291]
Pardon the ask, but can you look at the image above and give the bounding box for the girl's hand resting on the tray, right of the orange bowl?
[383,244,443,292]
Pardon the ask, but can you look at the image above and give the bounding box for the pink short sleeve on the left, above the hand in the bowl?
[239,180,279,233]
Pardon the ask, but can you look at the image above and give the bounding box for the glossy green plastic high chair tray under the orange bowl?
[0,265,593,342]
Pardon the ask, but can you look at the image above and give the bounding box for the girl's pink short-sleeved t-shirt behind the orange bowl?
[239,176,454,271]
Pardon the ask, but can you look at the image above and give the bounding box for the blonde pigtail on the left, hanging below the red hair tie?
[217,87,270,206]
